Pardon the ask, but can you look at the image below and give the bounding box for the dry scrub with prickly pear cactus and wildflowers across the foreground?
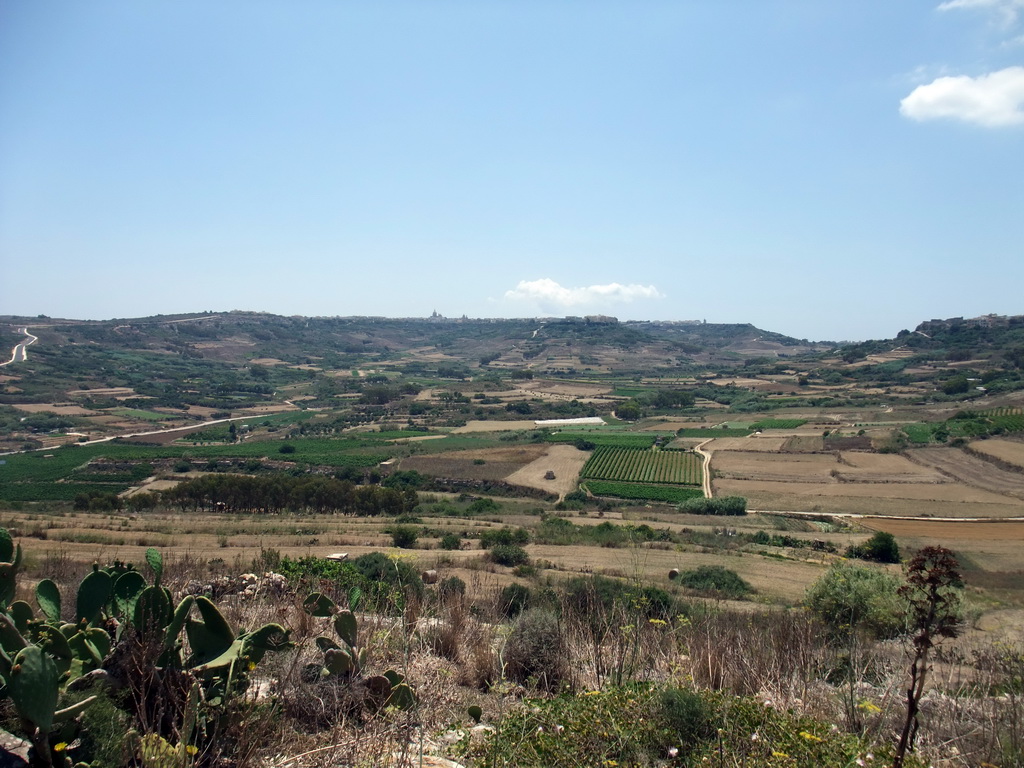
[0,521,1024,768]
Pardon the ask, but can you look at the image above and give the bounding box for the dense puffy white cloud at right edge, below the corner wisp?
[899,65,1024,128]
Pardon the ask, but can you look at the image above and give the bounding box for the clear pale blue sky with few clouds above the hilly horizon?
[0,0,1024,340]
